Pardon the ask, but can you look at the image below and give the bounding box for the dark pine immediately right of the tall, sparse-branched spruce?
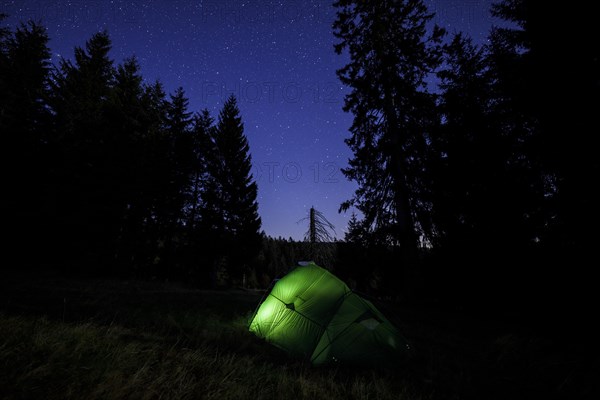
[433,34,494,247]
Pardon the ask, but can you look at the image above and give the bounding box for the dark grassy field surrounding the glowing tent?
[0,277,594,400]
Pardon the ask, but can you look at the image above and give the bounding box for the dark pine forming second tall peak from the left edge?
[51,32,120,264]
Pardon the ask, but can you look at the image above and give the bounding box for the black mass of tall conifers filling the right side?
[333,0,600,306]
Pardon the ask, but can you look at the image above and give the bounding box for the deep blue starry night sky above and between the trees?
[0,0,498,239]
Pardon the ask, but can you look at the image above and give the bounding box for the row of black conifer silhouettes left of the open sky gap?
[0,16,262,285]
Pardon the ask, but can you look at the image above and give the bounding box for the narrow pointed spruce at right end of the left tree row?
[213,96,261,277]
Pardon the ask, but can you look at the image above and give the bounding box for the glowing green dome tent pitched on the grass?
[250,263,409,365]
